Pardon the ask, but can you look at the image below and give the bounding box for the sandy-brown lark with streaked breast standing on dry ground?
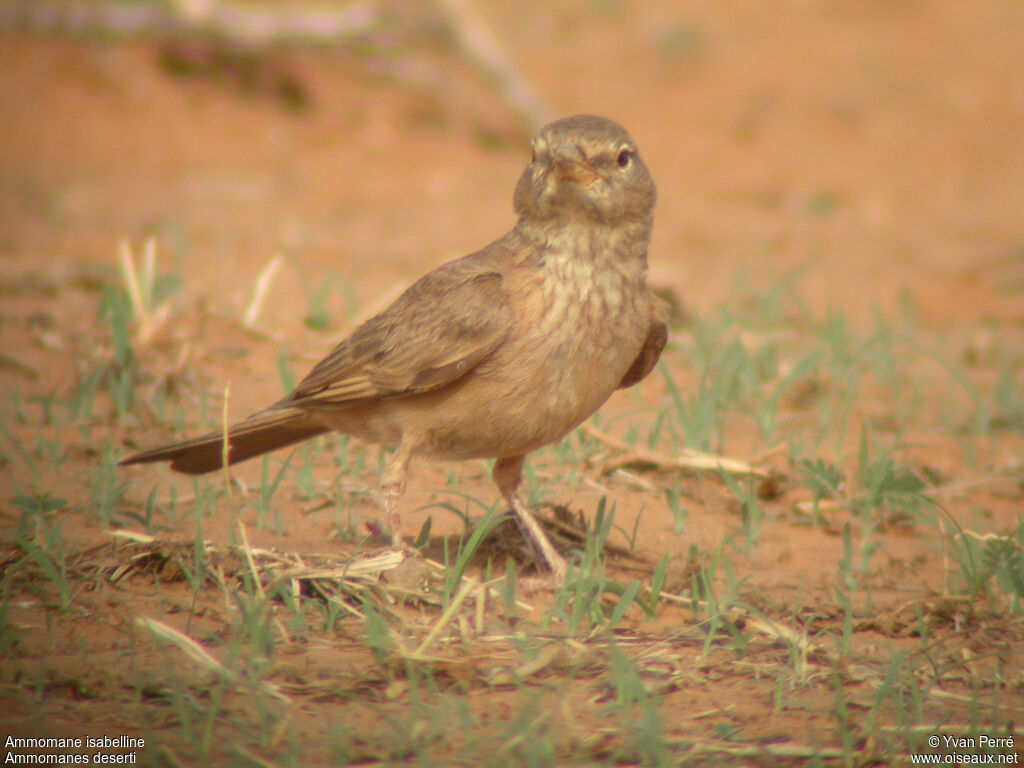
[120,115,668,582]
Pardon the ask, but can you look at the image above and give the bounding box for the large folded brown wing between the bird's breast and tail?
[281,255,512,408]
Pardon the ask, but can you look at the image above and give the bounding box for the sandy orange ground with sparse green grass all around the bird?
[0,6,1024,766]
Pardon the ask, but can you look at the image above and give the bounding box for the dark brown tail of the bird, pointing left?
[120,408,330,475]
